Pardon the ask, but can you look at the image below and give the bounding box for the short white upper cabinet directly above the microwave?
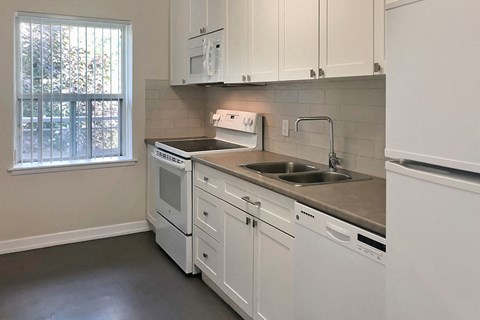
[188,0,225,38]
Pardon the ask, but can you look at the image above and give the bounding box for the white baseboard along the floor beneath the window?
[0,220,150,254]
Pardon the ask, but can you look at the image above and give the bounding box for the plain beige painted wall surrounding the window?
[0,0,168,241]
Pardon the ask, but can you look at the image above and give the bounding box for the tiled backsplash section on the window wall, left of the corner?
[145,80,206,138]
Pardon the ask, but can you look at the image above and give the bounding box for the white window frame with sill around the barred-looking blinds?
[9,12,137,175]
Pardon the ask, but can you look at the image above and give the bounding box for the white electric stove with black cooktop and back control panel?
[151,110,263,273]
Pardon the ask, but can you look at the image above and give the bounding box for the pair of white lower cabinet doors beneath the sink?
[221,199,294,320]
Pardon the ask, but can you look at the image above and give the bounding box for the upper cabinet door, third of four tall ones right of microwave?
[279,0,319,80]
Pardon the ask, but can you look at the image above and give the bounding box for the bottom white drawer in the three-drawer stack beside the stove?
[193,226,222,284]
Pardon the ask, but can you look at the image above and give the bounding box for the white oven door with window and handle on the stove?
[151,152,192,235]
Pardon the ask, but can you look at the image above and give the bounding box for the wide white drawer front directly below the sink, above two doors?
[223,176,295,235]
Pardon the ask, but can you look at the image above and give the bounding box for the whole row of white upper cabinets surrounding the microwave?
[171,0,386,85]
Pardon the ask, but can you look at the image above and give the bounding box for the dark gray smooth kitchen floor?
[0,232,241,320]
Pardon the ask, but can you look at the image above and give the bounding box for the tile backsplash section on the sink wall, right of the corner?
[206,77,385,177]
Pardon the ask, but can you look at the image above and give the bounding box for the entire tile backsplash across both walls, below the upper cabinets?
[146,77,385,177]
